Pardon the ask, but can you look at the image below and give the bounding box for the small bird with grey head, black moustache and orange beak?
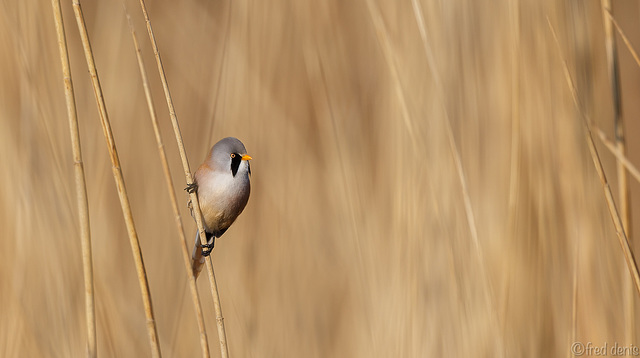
[186,137,252,278]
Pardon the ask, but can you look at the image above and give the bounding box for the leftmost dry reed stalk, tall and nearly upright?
[51,0,97,358]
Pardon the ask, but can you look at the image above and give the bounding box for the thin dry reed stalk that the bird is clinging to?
[135,0,229,358]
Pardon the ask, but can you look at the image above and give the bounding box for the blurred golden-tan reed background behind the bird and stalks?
[0,0,640,357]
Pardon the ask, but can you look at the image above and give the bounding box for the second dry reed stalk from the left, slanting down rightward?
[73,0,162,358]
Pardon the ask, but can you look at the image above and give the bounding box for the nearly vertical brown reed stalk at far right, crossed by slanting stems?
[600,0,635,342]
